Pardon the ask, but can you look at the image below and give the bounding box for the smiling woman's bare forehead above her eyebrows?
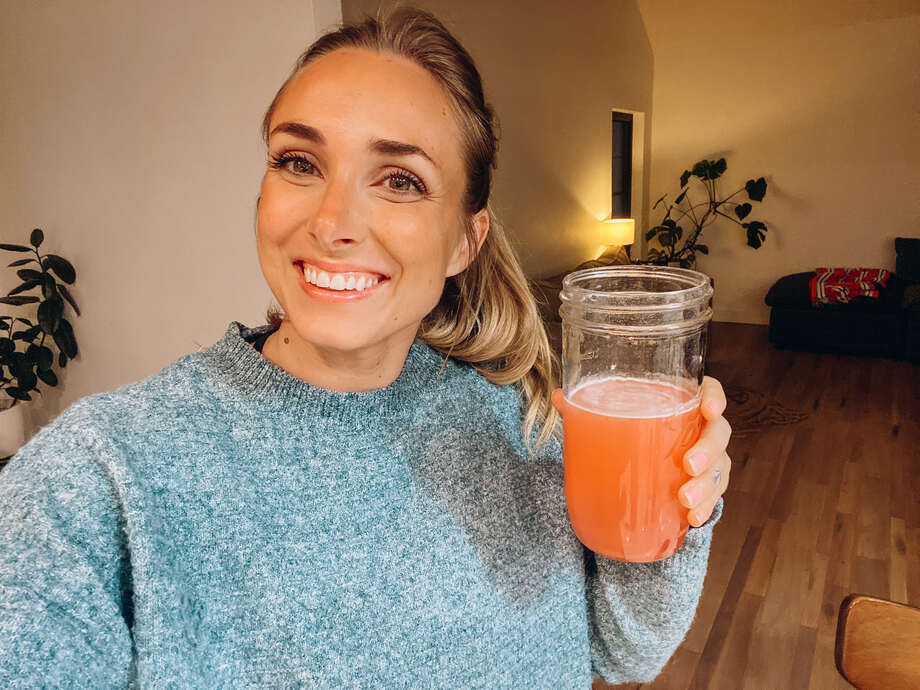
[270,48,460,162]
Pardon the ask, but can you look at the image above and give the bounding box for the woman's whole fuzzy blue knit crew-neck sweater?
[0,322,722,688]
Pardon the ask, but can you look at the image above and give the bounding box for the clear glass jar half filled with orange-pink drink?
[554,265,712,562]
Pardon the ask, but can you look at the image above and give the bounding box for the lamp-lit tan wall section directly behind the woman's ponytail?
[342,0,652,277]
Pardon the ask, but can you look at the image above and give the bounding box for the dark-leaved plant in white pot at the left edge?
[0,228,80,460]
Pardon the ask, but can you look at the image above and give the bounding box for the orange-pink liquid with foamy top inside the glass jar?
[554,378,702,562]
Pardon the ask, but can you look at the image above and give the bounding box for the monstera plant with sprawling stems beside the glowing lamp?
[637,158,767,268]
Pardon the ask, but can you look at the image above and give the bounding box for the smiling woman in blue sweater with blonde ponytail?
[0,9,730,687]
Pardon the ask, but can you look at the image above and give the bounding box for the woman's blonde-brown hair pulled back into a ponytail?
[262,6,560,453]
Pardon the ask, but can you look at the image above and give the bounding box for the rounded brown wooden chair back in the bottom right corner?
[835,594,920,690]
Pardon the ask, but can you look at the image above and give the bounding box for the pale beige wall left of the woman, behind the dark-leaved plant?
[0,0,340,430]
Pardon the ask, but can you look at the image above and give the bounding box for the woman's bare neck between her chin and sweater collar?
[262,319,416,393]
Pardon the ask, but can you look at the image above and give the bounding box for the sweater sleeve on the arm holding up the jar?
[585,498,724,684]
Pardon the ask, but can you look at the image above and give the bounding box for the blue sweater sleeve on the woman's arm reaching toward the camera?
[0,408,133,688]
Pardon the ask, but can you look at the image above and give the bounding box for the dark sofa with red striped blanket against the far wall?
[765,237,920,363]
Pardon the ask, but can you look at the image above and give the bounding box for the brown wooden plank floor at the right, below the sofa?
[594,324,920,690]
